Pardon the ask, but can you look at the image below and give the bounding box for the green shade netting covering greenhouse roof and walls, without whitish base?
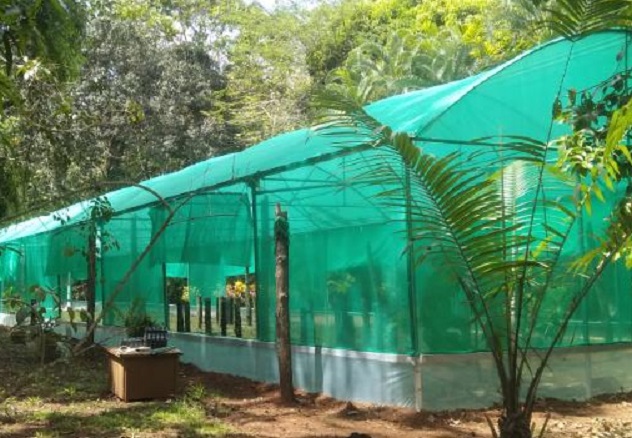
[0,31,632,354]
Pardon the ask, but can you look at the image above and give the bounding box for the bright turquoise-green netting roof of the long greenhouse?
[0,31,629,242]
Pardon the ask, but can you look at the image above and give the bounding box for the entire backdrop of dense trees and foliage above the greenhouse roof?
[0,0,543,219]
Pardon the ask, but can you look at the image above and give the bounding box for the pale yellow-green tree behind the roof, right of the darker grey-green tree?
[226,3,311,147]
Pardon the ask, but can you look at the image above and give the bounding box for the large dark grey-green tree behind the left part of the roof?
[1,2,235,216]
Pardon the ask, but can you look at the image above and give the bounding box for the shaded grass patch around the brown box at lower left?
[0,329,231,437]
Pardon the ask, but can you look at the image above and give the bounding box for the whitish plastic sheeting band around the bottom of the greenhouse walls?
[9,318,632,410]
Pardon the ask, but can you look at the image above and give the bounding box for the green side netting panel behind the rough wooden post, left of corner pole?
[257,151,412,353]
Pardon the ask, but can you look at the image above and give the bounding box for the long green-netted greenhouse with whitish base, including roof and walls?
[0,31,632,409]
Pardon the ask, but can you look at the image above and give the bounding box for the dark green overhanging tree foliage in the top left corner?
[0,0,84,218]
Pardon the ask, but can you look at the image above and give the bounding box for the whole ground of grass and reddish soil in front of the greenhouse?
[0,329,632,438]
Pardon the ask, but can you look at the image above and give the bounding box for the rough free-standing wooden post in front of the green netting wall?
[274,204,295,404]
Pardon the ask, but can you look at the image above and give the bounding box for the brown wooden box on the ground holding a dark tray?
[106,348,181,402]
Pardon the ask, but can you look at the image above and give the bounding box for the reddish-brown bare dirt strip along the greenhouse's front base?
[182,365,632,438]
